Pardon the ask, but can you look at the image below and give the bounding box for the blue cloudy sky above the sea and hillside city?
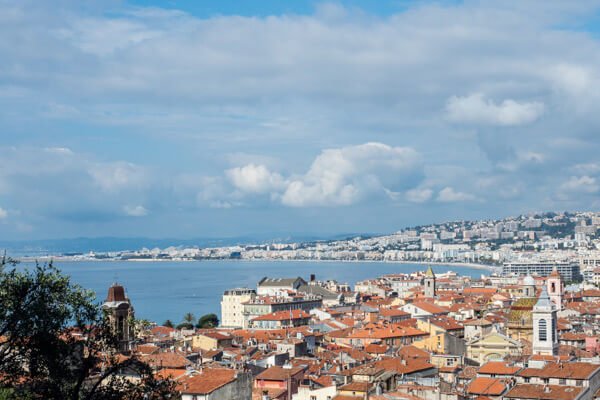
[0,0,600,240]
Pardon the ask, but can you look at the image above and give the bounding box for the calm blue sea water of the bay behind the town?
[22,261,486,323]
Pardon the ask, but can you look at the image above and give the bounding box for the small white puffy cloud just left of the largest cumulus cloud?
[225,164,284,194]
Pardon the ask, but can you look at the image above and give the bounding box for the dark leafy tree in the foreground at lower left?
[0,257,174,400]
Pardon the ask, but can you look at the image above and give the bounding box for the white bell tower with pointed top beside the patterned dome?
[532,286,558,356]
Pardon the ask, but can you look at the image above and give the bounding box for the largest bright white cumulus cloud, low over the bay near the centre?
[281,143,423,207]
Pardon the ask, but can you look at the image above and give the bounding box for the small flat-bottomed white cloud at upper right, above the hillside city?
[446,93,544,126]
